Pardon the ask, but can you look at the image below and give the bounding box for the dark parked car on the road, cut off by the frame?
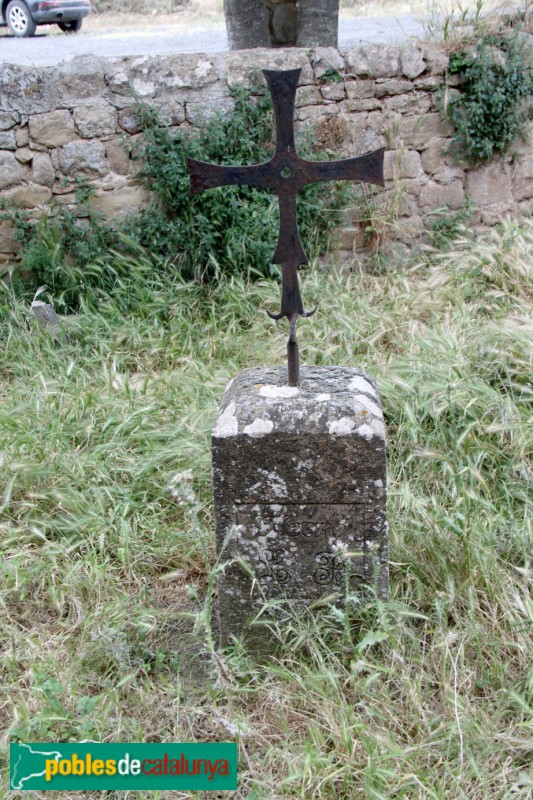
[0,0,91,36]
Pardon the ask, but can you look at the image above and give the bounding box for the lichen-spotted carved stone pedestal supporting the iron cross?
[212,367,388,646]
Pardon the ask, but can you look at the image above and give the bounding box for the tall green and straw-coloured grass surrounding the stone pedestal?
[0,222,533,800]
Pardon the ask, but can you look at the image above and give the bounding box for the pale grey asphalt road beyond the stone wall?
[0,16,423,66]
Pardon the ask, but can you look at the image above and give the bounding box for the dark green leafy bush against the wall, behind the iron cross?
[126,81,346,280]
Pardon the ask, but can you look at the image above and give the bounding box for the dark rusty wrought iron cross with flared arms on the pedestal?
[188,69,385,386]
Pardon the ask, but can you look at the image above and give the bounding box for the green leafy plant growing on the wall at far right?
[446,35,533,165]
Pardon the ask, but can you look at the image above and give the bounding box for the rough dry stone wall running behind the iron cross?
[0,44,533,262]
